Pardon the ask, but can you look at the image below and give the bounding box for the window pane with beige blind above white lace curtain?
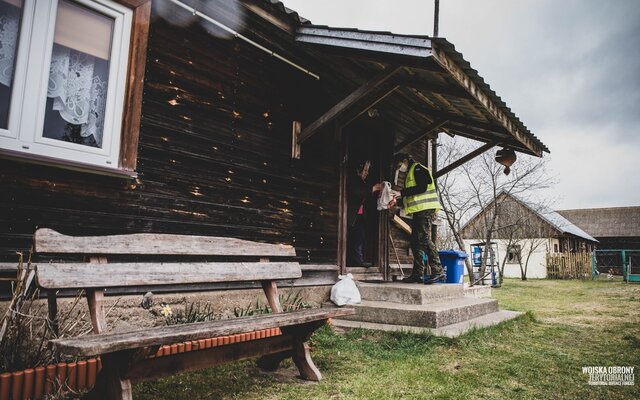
[43,0,113,147]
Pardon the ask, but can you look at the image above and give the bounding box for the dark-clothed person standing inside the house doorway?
[347,160,372,267]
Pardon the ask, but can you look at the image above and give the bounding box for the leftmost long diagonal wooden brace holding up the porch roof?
[299,65,402,143]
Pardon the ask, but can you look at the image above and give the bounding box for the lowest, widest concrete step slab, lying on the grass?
[333,310,523,337]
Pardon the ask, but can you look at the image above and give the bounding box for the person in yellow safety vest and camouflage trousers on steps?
[393,153,446,283]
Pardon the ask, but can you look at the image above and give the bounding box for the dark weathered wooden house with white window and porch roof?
[0,0,548,289]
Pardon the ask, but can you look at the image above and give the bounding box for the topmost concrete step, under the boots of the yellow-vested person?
[356,282,464,304]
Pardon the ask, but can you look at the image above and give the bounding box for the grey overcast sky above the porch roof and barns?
[283,0,640,209]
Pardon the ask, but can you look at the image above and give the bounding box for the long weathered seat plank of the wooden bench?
[51,308,355,356]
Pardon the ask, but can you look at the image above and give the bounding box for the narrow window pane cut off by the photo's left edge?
[0,0,22,129]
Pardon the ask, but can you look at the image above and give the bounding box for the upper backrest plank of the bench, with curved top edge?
[34,228,296,257]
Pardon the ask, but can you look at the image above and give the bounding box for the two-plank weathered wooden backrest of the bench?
[34,228,302,289]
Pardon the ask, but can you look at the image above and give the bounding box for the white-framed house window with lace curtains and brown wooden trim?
[0,0,150,174]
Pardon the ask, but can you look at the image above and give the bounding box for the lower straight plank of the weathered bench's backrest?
[36,262,302,289]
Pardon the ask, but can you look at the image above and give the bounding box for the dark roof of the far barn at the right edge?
[558,207,640,238]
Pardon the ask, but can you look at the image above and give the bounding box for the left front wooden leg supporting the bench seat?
[85,352,133,400]
